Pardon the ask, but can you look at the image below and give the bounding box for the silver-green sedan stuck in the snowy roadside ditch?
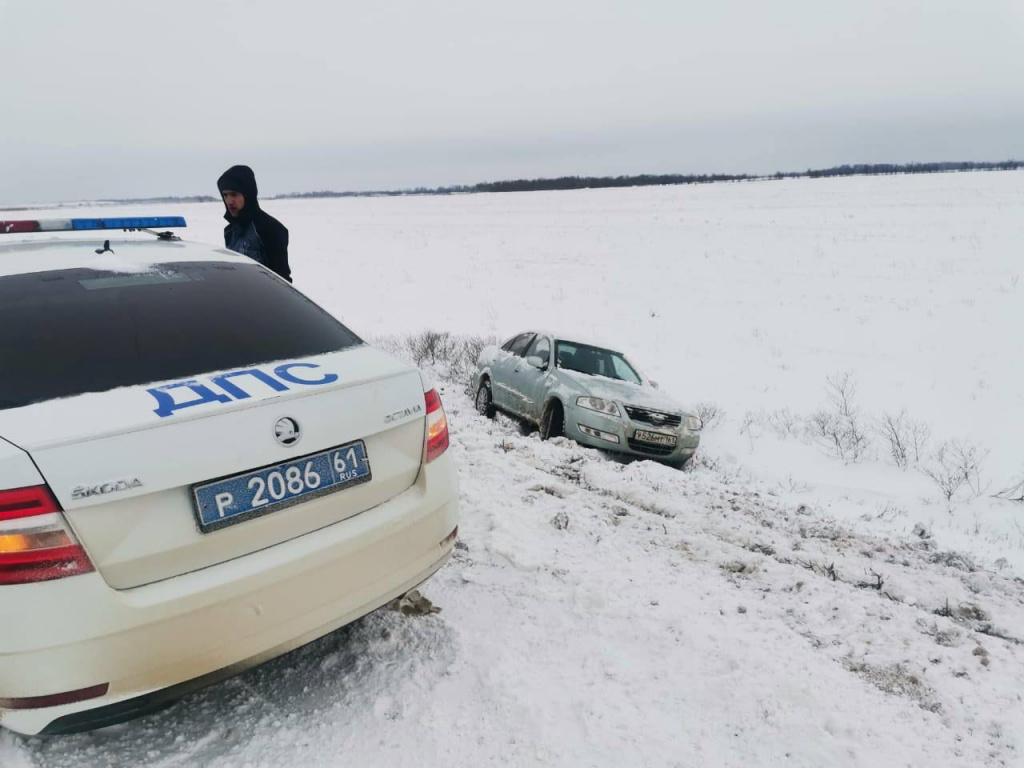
[473,332,702,468]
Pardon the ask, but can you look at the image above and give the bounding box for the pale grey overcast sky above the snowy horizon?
[0,0,1024,204]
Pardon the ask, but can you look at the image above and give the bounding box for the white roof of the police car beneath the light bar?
[0,234,253,278]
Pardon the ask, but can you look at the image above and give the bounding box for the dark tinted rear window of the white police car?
[0,261,362,410]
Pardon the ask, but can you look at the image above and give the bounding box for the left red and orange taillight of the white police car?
[0,485,92,585]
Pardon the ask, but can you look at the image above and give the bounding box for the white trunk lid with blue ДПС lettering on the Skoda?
[0,345,424,589]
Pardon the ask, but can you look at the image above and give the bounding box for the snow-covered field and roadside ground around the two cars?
[0,172,1024,768]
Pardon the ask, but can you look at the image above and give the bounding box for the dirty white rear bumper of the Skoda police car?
[0,455,459,734]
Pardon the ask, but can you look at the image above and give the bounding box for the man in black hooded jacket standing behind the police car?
[217,165,292,283]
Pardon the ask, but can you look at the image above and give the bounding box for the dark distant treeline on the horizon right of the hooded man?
[278,160,1024,199]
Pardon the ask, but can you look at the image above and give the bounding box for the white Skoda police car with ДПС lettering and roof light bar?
[0,217,458,734]
